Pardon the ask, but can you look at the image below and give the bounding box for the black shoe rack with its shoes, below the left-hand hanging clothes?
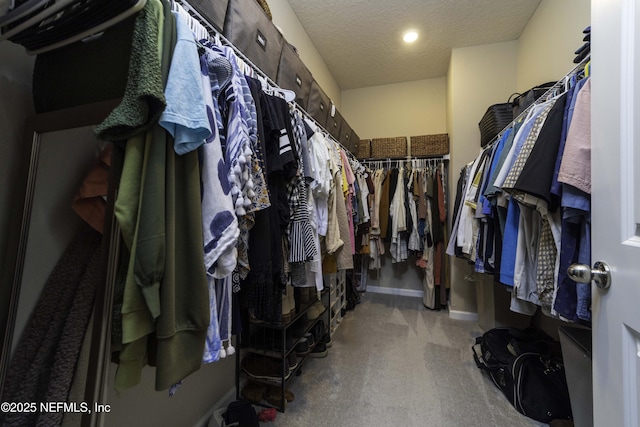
[236,288,331,412]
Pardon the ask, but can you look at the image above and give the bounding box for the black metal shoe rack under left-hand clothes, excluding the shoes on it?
[236,288,331,412]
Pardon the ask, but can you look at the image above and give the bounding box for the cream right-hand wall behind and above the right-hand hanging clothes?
[447,41,518,313]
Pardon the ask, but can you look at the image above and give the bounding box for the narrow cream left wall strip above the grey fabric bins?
[269,0,342,108]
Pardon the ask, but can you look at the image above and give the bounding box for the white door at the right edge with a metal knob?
[591,0,640,427]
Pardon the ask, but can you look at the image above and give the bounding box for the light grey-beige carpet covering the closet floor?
[263,293,545,427]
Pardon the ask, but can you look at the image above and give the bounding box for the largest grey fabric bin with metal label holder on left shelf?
[223,0,284,81]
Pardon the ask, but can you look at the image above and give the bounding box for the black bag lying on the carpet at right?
[472,328,572,423]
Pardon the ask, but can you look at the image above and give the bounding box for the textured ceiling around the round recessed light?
[288,0,540,90]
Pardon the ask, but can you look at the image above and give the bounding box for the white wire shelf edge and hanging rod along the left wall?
[171,0,360,170]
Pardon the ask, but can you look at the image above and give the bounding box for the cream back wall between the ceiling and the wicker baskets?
[340,77,447,139]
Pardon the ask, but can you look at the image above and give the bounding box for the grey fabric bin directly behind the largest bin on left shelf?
[276,40,313,107]
